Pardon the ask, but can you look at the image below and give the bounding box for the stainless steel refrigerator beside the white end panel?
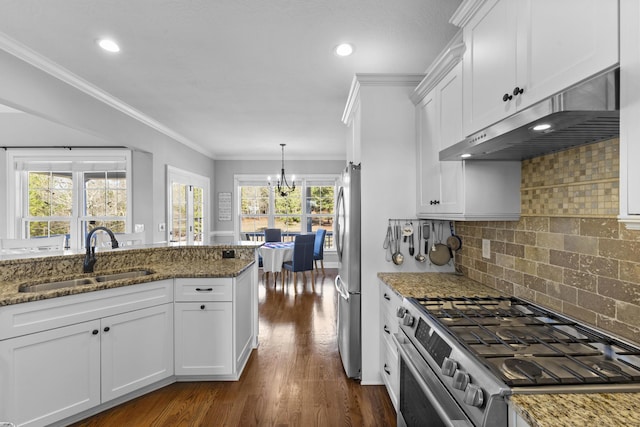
[334,163,362,379]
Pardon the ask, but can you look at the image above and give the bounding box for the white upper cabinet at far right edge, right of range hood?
[619,0,640,230]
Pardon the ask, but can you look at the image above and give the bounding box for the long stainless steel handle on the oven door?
[392,333,473,427]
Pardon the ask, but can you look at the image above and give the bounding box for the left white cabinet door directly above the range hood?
[463,0,516,136]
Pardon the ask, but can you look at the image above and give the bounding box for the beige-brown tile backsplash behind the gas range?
[456,139,640,343]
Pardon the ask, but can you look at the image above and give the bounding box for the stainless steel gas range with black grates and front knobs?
[394,297,640,427]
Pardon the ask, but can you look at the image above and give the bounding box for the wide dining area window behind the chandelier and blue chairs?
[236,175,338,249]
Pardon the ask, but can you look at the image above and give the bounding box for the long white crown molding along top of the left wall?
[0,32,214,158]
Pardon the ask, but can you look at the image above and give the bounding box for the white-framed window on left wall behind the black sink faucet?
[7,149,131,249]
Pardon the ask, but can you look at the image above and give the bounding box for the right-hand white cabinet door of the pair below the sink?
[101,304,173,402]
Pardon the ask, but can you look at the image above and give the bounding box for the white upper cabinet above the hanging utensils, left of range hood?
[411,36,520,221]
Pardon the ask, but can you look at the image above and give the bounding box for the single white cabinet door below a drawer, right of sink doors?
[175,302,233,375]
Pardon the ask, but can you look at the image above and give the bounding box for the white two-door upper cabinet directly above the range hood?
[460,0,619,136]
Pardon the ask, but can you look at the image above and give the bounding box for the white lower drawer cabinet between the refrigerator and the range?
[380,282,402,411]
